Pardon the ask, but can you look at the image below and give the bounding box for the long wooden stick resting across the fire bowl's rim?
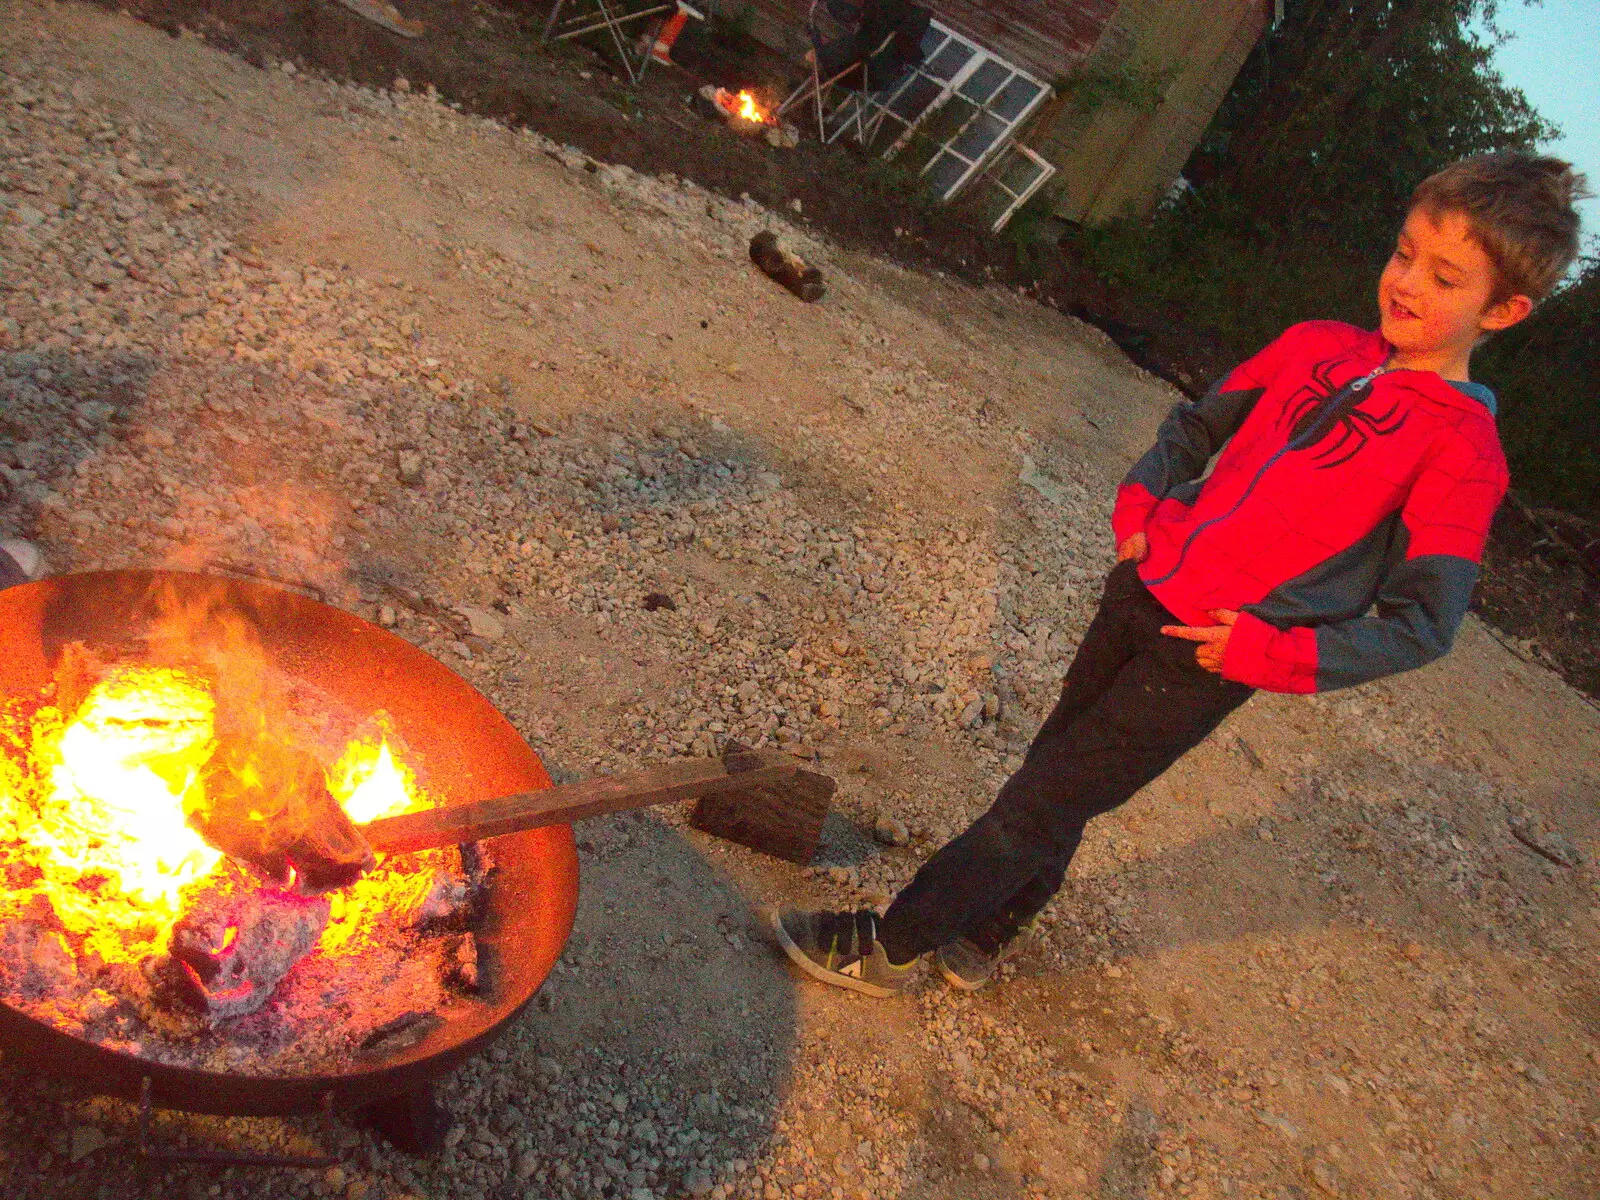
[360,750,800,853]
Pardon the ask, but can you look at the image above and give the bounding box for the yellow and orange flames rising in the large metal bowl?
[0,572,448,1024]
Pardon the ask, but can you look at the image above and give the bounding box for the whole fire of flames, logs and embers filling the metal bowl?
[0,620,480,1074]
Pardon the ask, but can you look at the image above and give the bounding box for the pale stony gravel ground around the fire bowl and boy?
[0,0,1600,1200]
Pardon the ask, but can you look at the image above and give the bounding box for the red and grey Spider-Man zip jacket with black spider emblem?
[1112,322,1509,693]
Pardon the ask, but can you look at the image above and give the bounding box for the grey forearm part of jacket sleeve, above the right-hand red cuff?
[1317,554,1478,691]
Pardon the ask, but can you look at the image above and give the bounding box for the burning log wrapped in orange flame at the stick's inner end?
[195,738,373,891]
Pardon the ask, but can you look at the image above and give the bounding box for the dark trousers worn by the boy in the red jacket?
[878,563,1253,962]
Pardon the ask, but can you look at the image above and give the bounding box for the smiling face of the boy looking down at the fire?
[1378,208,1533,378]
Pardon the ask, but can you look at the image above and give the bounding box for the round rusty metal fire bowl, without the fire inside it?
[0,571,578,1117]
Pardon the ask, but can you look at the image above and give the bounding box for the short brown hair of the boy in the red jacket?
[1411,150,1589,302]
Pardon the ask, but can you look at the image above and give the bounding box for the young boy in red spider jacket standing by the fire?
[773,154,1582,997]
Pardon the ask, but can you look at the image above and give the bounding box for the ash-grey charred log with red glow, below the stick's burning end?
[171,888,330,1021]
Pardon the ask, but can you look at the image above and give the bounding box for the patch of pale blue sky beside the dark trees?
[1494,0,1600,253]
